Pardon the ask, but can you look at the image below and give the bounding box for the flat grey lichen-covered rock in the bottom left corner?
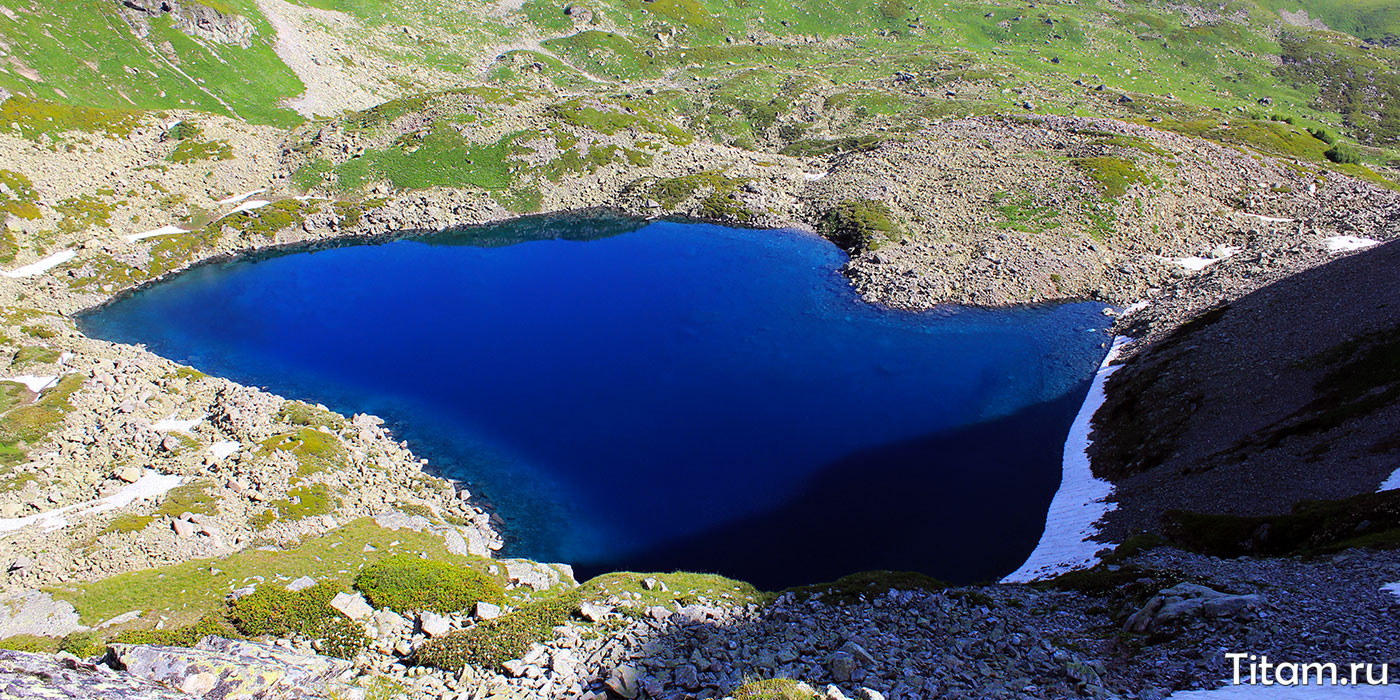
[0,650,189,700]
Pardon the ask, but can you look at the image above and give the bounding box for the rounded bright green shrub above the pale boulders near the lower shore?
[354,554,505,613]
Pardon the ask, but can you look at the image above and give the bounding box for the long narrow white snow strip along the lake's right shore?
[1001,336,1133,584]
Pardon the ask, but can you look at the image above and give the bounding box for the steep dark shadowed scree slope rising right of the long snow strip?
[1092,244,1400,539]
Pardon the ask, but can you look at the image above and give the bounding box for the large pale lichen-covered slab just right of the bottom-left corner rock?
[109,637,354,700]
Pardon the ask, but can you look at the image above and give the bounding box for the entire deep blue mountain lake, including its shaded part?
[81,214,1107,588]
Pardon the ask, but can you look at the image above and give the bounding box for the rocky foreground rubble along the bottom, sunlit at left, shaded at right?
[0,549,1400,700]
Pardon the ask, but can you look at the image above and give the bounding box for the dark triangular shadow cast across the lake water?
[575,382,1089,591]
